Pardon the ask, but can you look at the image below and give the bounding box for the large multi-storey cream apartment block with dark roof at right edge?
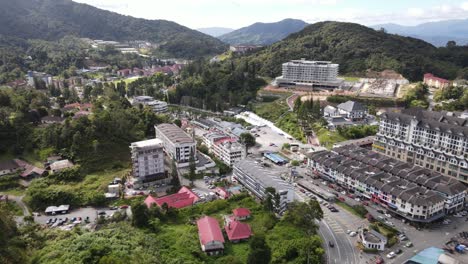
[373,109,468,183]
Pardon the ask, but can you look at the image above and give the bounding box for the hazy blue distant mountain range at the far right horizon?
[372,19,468,47]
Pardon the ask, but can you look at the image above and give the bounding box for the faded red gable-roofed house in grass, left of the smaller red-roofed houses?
[197,216,224,255]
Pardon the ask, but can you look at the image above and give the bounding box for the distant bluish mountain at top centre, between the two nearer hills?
[219,19,307,46]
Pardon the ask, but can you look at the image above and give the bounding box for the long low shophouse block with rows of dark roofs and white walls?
[308,145,466,223]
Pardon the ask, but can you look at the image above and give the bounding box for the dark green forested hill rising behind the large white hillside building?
[247,21,468,80]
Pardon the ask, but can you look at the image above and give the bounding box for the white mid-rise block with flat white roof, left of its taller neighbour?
[130,138,171,188]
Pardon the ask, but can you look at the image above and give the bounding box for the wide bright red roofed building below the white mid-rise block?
[145,186,200,209]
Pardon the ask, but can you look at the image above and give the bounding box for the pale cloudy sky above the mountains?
[74,0,468,29]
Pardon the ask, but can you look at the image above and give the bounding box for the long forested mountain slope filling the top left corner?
[0,0,227,58]
